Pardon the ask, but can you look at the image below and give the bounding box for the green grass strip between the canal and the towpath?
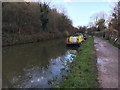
[60,37,98,88]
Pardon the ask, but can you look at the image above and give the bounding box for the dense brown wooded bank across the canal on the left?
[2,2,75,46]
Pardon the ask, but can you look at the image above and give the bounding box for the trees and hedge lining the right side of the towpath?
[83,1,120,48]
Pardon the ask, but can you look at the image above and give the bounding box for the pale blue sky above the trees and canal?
[27,0,117,27]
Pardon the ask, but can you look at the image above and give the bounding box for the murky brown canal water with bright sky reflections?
[2,39,76,88]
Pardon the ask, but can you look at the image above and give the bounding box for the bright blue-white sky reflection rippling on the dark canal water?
[6,51,76,88]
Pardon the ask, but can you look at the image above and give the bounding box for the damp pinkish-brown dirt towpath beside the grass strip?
[94,37,118,88]
